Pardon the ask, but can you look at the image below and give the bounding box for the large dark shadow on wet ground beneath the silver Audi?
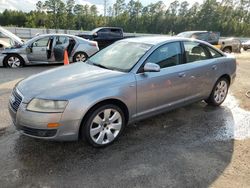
[0,102,234,187]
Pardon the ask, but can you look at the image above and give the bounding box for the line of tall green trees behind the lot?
[0,0,250,37]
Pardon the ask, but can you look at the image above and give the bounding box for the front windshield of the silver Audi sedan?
[89,41,152,72]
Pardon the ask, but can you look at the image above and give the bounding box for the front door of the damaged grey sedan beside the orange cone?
[27,37,51,62]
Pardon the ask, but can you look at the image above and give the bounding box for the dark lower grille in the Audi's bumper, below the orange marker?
[20,126,57,137]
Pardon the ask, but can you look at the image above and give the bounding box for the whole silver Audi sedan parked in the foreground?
[9,37,236,147]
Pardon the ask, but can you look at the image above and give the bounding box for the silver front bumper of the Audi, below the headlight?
[9,100,80,141]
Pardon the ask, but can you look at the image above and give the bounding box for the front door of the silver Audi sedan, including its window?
[136,42,191,116]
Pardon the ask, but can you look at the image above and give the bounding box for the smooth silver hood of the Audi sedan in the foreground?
[17,63,128,103]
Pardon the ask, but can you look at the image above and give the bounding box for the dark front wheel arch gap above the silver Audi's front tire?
[78,98,129,138]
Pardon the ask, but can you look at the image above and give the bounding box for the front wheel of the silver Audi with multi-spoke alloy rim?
[81,104,125,147]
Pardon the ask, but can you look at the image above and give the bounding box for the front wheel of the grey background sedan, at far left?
[4,54,24,68]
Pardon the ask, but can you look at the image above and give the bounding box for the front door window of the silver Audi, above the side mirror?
[146,42,181,68]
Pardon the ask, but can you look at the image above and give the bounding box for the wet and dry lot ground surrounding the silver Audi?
[0,53,250,187]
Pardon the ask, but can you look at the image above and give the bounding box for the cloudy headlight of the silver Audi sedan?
[27,99,68,112]
